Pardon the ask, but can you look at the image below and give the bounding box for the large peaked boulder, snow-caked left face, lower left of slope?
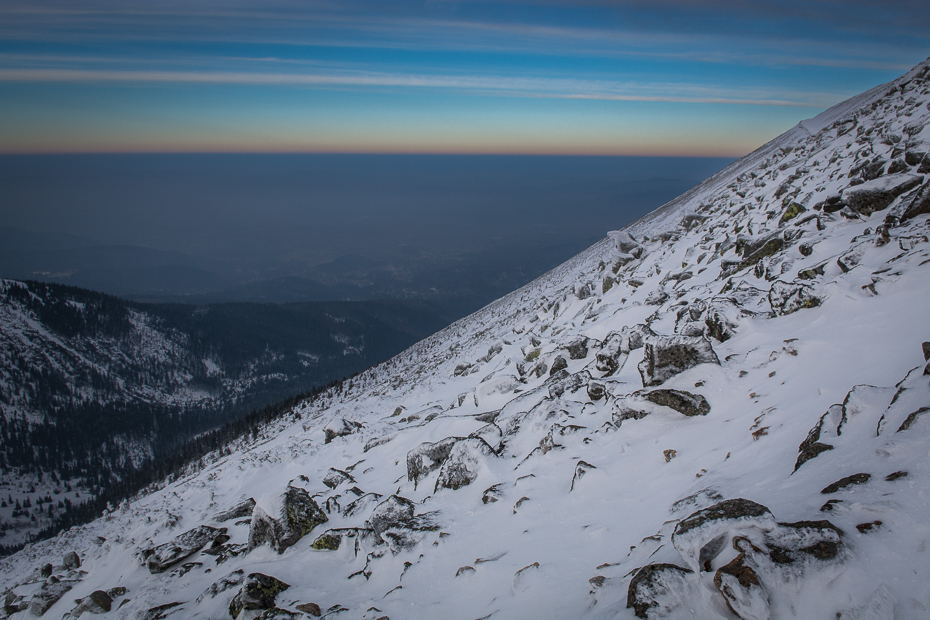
[249,486,329,553]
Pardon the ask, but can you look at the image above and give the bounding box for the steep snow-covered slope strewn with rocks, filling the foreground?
[0,63,930,620]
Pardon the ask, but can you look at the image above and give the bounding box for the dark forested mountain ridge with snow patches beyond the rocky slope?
[0,280,445,544]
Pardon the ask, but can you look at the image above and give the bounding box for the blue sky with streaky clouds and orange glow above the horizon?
[0,0,930,156]
